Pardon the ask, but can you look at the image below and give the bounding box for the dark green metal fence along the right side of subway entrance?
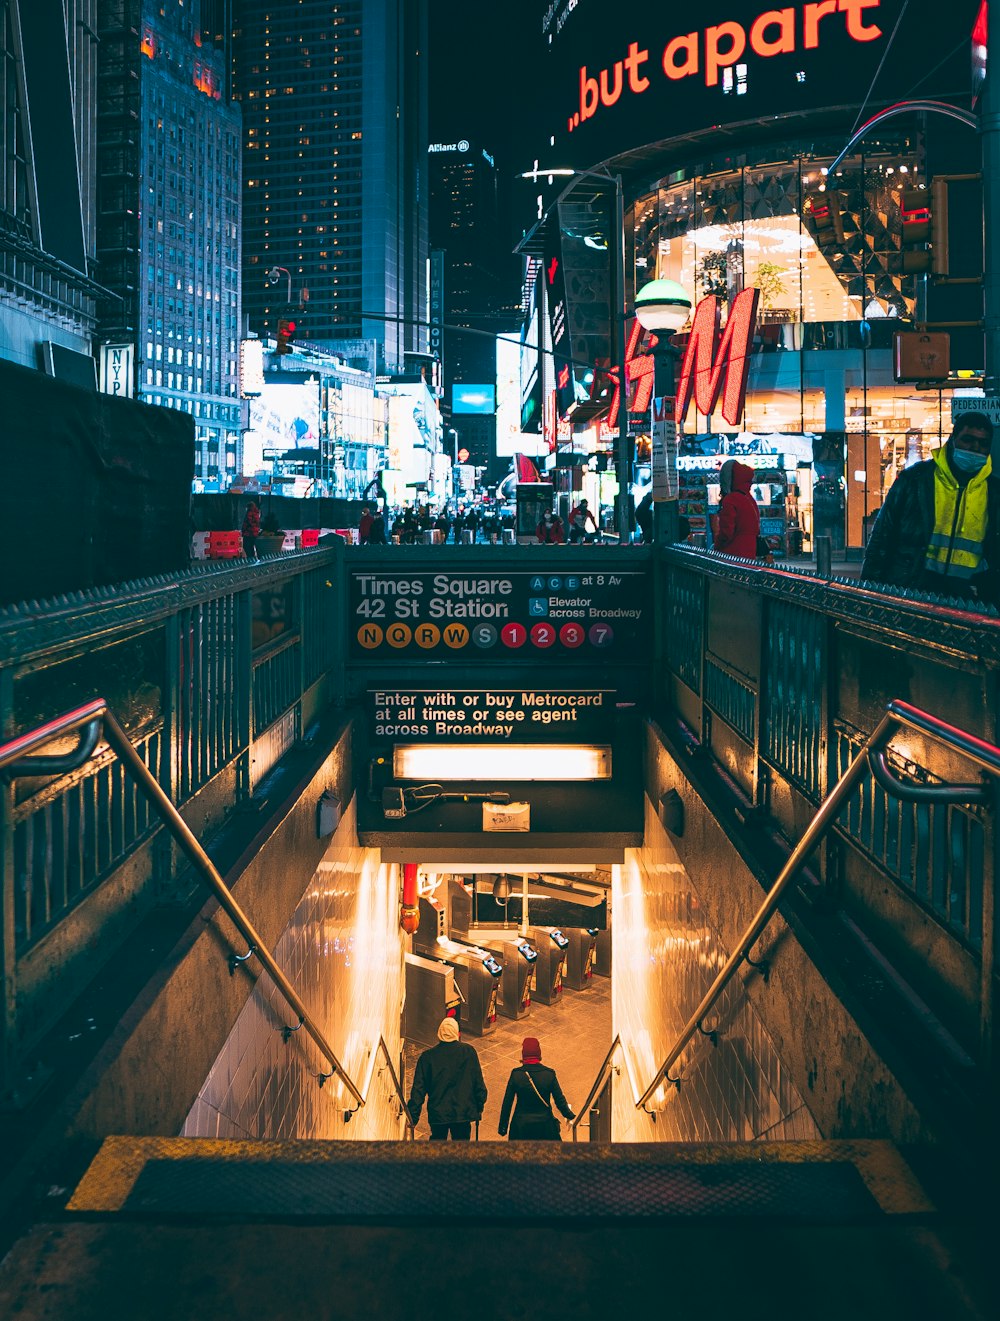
[657,548,1000,1040]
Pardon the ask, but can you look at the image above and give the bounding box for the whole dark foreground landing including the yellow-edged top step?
[0,1137,995,1321]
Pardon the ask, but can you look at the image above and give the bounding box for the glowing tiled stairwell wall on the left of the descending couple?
[182,807,403,1139]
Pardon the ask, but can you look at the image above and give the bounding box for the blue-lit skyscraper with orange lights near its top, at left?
[98,0,240,489]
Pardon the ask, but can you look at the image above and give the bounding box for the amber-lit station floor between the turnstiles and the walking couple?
[404,976,612,1143]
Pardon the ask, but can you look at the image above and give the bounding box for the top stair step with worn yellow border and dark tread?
[66,1137,933,1225]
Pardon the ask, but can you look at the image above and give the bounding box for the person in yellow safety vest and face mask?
[861,412,1000,604]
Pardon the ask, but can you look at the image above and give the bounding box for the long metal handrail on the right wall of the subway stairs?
[635,700,1000,1114]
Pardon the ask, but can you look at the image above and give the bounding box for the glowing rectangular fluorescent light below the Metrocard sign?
[392,744,612,782]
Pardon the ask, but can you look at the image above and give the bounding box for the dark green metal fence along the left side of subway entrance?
[0,548,342,1062]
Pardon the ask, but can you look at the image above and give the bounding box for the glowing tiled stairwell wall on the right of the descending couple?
[612,799,822,1143]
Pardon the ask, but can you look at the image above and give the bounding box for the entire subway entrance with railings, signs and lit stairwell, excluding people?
[0,544,1000,1317]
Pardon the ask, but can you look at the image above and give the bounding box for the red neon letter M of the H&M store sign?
[678,289,761,427]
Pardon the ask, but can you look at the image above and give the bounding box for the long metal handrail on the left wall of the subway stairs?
[0,697,367,1119]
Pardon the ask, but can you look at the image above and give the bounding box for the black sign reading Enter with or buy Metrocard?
[367,686,616,744]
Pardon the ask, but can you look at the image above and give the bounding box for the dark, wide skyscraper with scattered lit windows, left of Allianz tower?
[234,0,427,371]
